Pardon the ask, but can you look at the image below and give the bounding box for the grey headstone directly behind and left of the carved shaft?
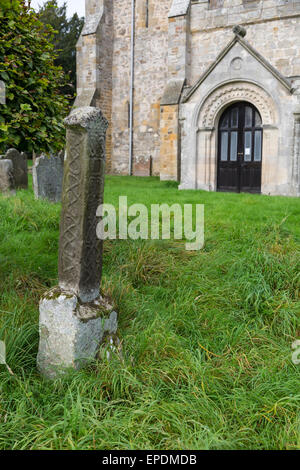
[32,155,64,202]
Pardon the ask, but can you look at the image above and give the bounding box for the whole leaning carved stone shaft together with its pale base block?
[37,107,118,378]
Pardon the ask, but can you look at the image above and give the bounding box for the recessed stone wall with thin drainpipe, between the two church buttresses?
[112,0,172,175]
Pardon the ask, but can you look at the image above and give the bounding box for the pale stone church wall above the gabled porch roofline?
[191,0,300,84]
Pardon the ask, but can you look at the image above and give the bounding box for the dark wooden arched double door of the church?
[217,102,263,193]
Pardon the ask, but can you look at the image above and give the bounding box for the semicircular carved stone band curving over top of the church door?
[199,83,275,128]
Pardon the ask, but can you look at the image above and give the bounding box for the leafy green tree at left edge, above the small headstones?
[0,0,69,153]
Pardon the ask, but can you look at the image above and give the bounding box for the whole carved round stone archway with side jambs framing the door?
[191,81,278,193]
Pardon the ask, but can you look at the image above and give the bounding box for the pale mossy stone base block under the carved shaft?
[37,288,118,379]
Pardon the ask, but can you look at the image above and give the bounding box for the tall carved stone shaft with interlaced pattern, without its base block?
[59,107,108,303]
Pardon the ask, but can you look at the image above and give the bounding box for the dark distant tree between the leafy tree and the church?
[39,0,84,95]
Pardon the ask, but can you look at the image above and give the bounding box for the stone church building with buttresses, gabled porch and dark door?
[75,0,300,196]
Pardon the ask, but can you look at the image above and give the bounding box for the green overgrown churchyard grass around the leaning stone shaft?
[0,177,300,450]
